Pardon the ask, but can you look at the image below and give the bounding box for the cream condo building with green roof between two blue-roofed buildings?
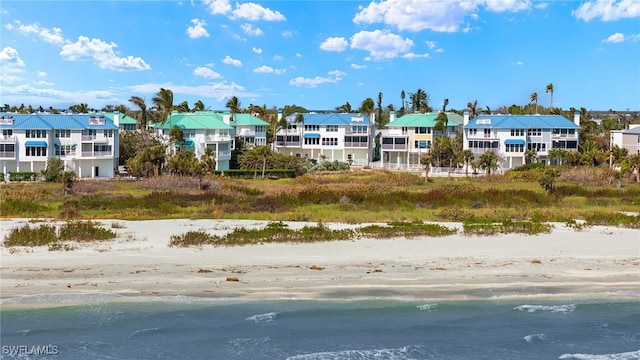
[380,111,463,170]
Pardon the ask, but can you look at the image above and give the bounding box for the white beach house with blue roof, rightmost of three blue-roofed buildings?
[463,112,580,171]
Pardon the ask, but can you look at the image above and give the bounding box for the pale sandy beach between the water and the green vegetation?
[0,219,640,307]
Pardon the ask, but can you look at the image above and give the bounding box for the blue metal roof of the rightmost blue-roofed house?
[465,115,580,129]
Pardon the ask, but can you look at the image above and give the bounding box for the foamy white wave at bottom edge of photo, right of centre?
[287,345,433,360]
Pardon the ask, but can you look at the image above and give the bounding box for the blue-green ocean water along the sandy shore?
[0,297,640,360]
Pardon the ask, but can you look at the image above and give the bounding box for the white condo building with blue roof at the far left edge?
[0,112,120,178]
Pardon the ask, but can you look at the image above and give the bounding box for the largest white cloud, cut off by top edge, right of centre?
[353,0,531,32]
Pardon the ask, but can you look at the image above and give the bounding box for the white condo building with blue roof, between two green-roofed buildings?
[274,113,375,166]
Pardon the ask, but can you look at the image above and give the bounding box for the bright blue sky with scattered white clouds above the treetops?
[0,0,640,110]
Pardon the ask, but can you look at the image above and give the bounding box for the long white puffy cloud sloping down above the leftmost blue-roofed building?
[60,36,151,71]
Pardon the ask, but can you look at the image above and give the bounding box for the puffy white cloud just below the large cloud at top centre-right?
[351,30,413,60]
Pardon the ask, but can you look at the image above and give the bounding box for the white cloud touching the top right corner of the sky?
[571,0,640,21]
